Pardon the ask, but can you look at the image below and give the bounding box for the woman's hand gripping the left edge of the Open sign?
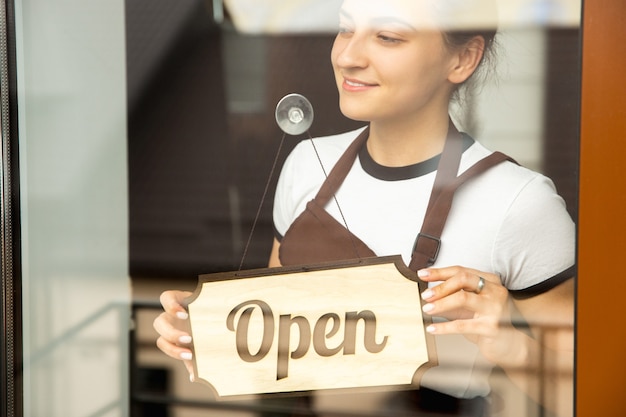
[153,291,194,381]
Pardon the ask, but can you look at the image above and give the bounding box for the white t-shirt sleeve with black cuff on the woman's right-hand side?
[493,175,576,297]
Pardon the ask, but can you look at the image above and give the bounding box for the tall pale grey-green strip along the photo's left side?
[16,0,130,417]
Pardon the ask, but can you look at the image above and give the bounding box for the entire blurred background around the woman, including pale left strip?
[3,0,580,417]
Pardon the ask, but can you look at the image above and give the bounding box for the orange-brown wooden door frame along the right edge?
[576,1,626,417]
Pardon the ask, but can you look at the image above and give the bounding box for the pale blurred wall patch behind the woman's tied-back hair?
[451,27,546,170]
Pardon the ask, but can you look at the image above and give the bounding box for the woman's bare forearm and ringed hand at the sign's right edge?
[419,267,574,416]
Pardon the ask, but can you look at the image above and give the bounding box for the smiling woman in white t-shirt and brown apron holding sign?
[155,0,574,415]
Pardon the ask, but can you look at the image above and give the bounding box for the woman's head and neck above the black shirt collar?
[331,1,485,161]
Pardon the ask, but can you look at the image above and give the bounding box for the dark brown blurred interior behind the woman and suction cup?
[126,0,580,280]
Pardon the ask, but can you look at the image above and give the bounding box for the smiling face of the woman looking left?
[331,0,454,122]
